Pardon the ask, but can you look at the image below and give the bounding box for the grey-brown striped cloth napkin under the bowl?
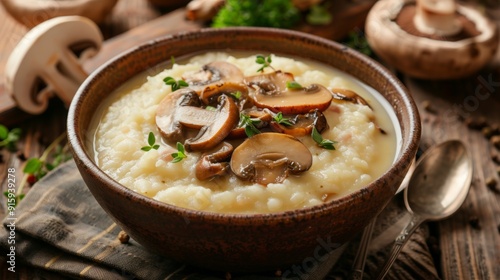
[0,161,438,280]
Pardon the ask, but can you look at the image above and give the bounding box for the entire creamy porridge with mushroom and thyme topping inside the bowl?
[93,52,399,213]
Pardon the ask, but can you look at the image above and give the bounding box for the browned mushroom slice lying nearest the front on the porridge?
[230,132,312,186]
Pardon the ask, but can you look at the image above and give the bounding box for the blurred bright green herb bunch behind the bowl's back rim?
[212,0,301,28]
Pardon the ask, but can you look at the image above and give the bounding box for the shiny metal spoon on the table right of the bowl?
[376,140,472,279]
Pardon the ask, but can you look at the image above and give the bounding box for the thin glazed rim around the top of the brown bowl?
[67,27,421,224]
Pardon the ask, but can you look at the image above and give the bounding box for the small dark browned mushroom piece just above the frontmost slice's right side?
[269,110,329,137]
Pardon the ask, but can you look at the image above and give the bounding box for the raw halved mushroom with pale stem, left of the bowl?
[5,16,103,114]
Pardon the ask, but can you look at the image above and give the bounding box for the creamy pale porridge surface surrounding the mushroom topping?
[93,52,399,213]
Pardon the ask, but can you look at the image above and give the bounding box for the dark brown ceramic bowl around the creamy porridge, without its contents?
[68,28,420,271]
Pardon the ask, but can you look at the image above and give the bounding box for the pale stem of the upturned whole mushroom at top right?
[413,0,462,36]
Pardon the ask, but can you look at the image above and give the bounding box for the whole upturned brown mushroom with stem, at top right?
[365,0,499,80]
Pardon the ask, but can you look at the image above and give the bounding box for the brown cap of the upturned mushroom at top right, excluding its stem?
[365,0,499,80]
